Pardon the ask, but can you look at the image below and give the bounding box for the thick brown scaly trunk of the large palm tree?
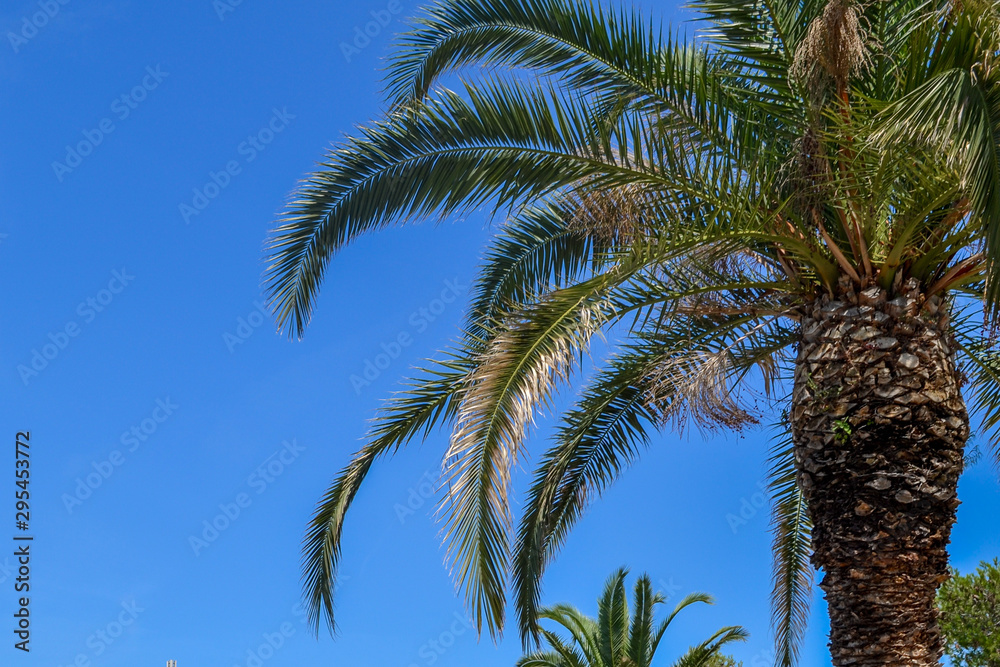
[790,280,969,667]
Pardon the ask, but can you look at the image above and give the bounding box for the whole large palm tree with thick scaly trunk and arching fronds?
[265,0,1000,667]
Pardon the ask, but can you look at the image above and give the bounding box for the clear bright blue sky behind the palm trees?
[0,0,1000,667]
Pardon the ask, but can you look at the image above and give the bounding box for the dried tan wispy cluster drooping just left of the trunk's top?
[646,350,760,431]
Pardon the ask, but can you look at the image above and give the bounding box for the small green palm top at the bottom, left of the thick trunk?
[517,569,748,667]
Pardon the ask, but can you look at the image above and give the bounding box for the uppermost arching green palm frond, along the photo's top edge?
[387,0,686,116]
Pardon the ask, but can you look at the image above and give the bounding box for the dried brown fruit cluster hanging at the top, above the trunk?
[790,0,870,95]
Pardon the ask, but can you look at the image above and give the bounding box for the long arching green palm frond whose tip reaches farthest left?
[265,81,593,335]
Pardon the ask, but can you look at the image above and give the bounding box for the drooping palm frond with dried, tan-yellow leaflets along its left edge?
[441,275,609,637]
